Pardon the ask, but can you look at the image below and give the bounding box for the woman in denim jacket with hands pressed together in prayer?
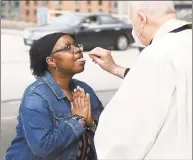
[5,32,103,160]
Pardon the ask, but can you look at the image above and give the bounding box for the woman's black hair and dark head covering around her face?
[29,32,75,77]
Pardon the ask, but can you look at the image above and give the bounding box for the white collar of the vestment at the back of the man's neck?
[152,19,190,43]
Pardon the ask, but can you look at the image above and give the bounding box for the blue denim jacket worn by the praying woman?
[5,72,103,160]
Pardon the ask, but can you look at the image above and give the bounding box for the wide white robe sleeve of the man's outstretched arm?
[94,58,175,160]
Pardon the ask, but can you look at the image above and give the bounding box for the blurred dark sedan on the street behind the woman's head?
[24,12,134,50]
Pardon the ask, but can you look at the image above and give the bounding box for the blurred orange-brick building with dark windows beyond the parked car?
[20,0,111,22]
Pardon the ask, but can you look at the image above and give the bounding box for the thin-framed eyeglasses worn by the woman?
[51,44,83,55]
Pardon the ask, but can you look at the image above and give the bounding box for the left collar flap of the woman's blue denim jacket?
[41,72,73,99]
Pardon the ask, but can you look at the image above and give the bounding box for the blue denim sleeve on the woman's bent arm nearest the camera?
[20,90,85,157]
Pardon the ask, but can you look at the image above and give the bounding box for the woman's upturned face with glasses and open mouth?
[47,35,85,75]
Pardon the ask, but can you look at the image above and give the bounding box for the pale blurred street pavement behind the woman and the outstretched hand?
[0,29,139,159]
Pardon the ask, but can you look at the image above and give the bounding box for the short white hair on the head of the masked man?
[130,1,176,17]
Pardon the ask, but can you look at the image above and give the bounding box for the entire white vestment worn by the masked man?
[94,19,192,160]
